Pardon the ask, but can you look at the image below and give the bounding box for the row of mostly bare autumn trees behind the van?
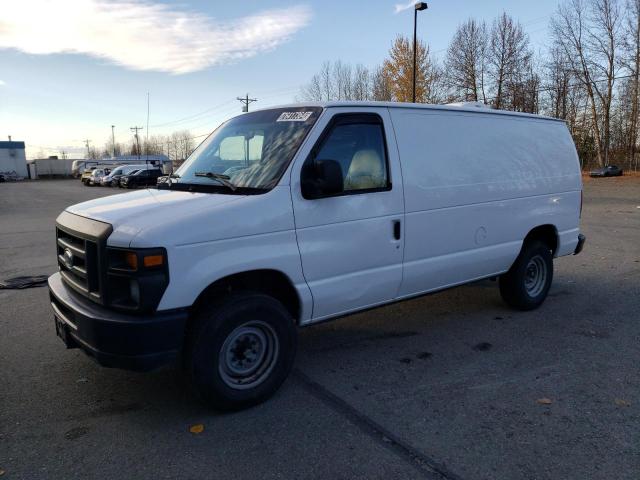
[300,0,640,169]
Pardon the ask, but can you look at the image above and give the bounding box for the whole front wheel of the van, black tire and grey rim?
[184,293,298,410]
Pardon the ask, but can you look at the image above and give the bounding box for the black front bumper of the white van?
[48,273,188,371]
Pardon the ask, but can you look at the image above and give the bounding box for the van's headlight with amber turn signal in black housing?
[105,248,169,312]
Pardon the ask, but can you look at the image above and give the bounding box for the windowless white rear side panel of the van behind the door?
[390,109,582,296]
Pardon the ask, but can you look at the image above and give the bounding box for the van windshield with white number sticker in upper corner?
[174,107,322,193]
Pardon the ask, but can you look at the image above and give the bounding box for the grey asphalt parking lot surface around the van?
[0,178,640,480]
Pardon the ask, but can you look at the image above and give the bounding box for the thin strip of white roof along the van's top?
[253,101,564,123]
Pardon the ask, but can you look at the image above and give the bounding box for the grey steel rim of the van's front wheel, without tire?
[218,320,280,390]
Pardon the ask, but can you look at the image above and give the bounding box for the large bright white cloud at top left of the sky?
[0,0,311,74]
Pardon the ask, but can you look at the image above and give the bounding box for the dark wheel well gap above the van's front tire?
[193,269,301,322]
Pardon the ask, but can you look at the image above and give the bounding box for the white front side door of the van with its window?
[291,108,404,320]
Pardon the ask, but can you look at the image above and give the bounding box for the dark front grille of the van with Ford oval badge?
[56,212,111,303]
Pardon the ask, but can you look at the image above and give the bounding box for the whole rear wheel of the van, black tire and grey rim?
[500,240,553,310]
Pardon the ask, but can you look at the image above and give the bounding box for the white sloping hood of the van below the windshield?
[67,189,245,246]
